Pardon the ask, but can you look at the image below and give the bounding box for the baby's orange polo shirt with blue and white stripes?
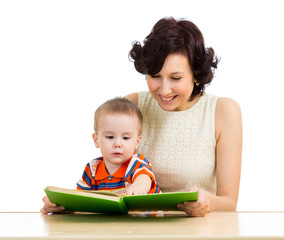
[77,154,160,195]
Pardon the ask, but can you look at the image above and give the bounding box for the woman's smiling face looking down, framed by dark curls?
[147,54,194,111]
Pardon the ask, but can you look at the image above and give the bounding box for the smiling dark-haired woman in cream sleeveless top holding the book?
[42,15,242,216]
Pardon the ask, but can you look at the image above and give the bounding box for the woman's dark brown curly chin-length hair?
[129,17,219,101]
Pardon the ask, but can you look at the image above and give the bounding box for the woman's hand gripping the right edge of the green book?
[177,186,210,217]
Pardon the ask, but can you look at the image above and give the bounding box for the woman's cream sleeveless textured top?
[137,91,217,194]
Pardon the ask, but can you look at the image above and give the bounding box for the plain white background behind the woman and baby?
[0,0,284,211]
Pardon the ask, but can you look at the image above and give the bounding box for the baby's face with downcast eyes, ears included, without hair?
[94,113,141,170]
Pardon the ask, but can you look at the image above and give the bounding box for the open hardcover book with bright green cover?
[44,186,198,214]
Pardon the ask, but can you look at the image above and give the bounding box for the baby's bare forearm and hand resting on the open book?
[126,174,152,195]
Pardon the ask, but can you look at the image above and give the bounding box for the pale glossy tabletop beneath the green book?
[0,212,284,240]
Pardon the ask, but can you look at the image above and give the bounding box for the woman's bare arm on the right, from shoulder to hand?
[179,98,242,216]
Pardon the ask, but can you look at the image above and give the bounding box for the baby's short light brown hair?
[94,97,143,135]
